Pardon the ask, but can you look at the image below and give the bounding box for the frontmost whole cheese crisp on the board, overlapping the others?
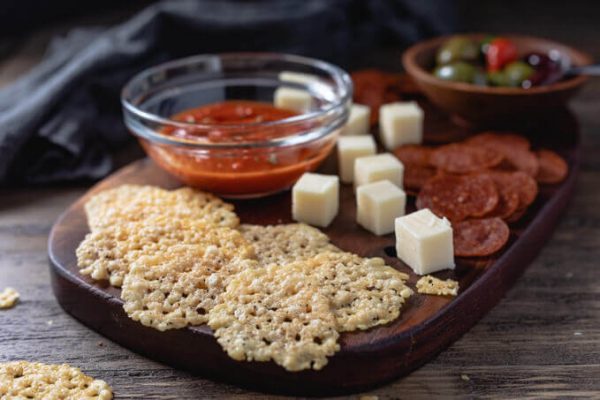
[208,264,339,371]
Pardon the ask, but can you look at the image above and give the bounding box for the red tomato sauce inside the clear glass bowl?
[142,100,335,197]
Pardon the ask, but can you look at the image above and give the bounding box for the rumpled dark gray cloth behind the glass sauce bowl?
[0,0,454,184]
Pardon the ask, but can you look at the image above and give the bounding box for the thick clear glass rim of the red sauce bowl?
[121,52,353,148]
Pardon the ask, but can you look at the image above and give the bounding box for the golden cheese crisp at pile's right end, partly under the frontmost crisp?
[302,253,412,332]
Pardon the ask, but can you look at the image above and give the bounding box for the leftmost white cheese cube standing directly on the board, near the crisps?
[292,172,340,227]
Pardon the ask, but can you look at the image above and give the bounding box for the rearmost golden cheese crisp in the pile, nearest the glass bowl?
[85,185,239,230]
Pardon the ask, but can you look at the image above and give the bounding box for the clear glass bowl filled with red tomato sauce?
[121,53,352,197]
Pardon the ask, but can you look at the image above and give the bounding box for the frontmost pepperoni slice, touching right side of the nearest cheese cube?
[452,218,510,257]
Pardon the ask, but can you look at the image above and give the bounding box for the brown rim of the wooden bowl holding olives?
[402,32,593,96]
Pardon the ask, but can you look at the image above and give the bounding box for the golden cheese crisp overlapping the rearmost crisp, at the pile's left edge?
[76,215,251,287]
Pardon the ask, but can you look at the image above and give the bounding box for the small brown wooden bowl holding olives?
[402,34,592,128]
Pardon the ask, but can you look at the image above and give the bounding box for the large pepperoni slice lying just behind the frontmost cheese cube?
[416,174,498,222]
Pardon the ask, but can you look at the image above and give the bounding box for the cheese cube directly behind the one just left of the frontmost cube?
[354,153,404,188]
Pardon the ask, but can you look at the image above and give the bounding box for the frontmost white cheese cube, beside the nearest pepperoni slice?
[396,208,454,275]
